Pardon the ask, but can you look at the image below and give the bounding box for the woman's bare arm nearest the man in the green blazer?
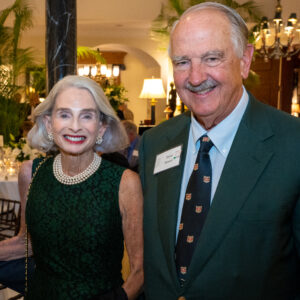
[119,170,144,300]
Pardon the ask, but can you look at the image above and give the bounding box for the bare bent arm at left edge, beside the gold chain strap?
[0,160,32,260]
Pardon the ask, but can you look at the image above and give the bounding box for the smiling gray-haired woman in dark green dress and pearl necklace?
[1,76,143,300]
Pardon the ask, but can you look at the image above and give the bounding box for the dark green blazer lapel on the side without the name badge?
[187,97,273,286]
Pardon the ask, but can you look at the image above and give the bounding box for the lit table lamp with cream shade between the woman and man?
[140,78,166,125]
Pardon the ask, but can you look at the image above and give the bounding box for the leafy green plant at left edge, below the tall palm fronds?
[0,95,30,144]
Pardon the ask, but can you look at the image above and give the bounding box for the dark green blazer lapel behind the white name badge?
[155,118,190,288]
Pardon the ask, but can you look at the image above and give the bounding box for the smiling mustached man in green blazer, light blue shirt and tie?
[140,2,300,300]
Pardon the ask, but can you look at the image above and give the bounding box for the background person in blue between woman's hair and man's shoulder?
[121,120,141,171]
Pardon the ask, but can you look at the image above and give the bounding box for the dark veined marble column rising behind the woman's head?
[46,0,77,92]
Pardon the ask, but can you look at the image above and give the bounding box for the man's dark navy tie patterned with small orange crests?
[175,135,213,284]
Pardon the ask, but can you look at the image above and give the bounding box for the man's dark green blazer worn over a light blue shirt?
[140,95,300,300]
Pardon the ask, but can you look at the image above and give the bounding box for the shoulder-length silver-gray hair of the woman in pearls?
[28,75,128,153]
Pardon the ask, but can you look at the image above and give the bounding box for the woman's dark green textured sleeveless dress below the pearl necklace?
[26,157,125,300]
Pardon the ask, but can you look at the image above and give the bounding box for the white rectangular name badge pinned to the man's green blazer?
[153,145,182,174]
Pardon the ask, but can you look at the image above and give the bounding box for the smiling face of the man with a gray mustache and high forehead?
[171,9,253,129]
